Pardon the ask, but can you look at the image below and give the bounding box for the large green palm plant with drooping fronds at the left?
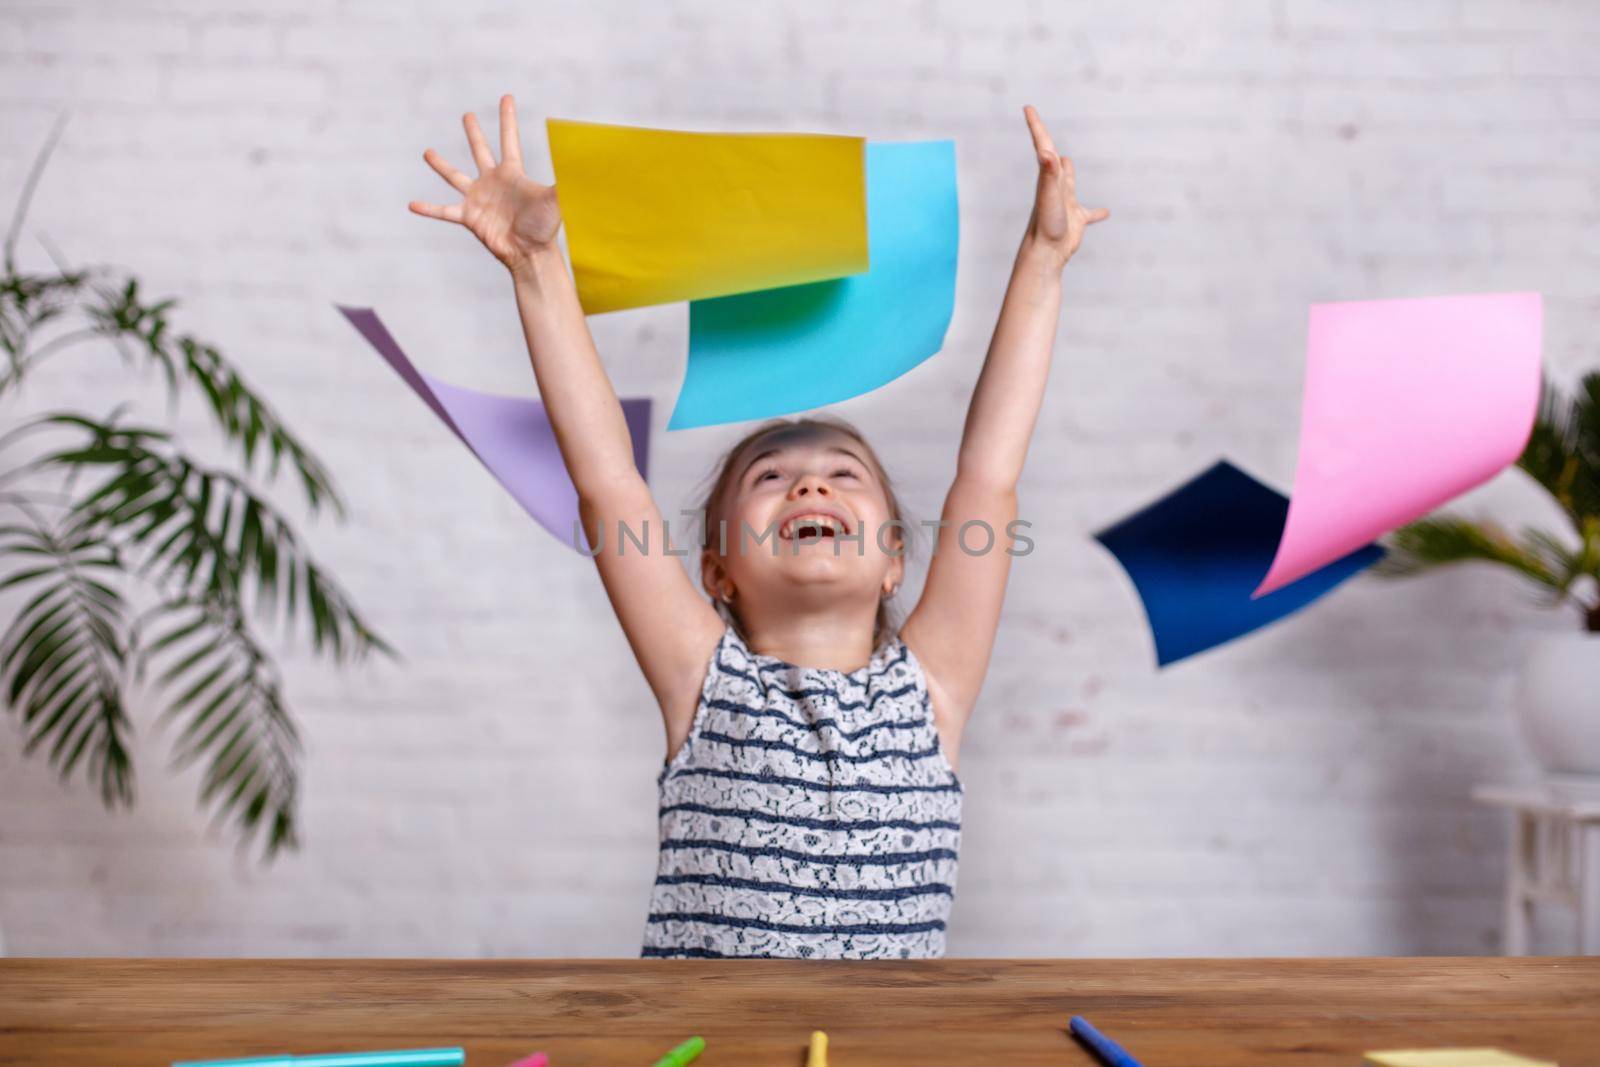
[0,123,390,857]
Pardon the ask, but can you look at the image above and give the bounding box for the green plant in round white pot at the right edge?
[1378,371,1600,783]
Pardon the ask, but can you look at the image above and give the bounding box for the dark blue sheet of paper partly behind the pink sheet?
[1094,459,1384,667]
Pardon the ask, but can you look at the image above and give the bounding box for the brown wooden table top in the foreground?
[0,957,1600,1067]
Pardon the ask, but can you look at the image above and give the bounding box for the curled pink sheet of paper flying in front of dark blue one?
[1251,293,1544,597]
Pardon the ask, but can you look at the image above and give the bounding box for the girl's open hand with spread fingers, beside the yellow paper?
[411,93,562,274]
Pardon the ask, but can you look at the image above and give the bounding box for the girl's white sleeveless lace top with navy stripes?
[640,625,962,960]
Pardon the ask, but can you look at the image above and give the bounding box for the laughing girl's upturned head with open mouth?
[702,427,906,621]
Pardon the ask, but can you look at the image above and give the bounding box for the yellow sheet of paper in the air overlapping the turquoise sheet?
[546,118,867,315]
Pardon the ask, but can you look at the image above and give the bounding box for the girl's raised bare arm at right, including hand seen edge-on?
[901,107,1110,760]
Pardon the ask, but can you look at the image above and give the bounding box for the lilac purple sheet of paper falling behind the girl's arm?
[334,304,650,550]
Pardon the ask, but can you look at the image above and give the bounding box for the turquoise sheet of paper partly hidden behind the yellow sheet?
[667,141,960,430]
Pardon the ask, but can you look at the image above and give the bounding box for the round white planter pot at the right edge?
[1517,632,1600,785]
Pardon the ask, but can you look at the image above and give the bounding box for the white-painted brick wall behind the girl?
[0,0,1600,957]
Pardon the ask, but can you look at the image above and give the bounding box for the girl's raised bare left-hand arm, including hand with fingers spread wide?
[411,94,723,752]
